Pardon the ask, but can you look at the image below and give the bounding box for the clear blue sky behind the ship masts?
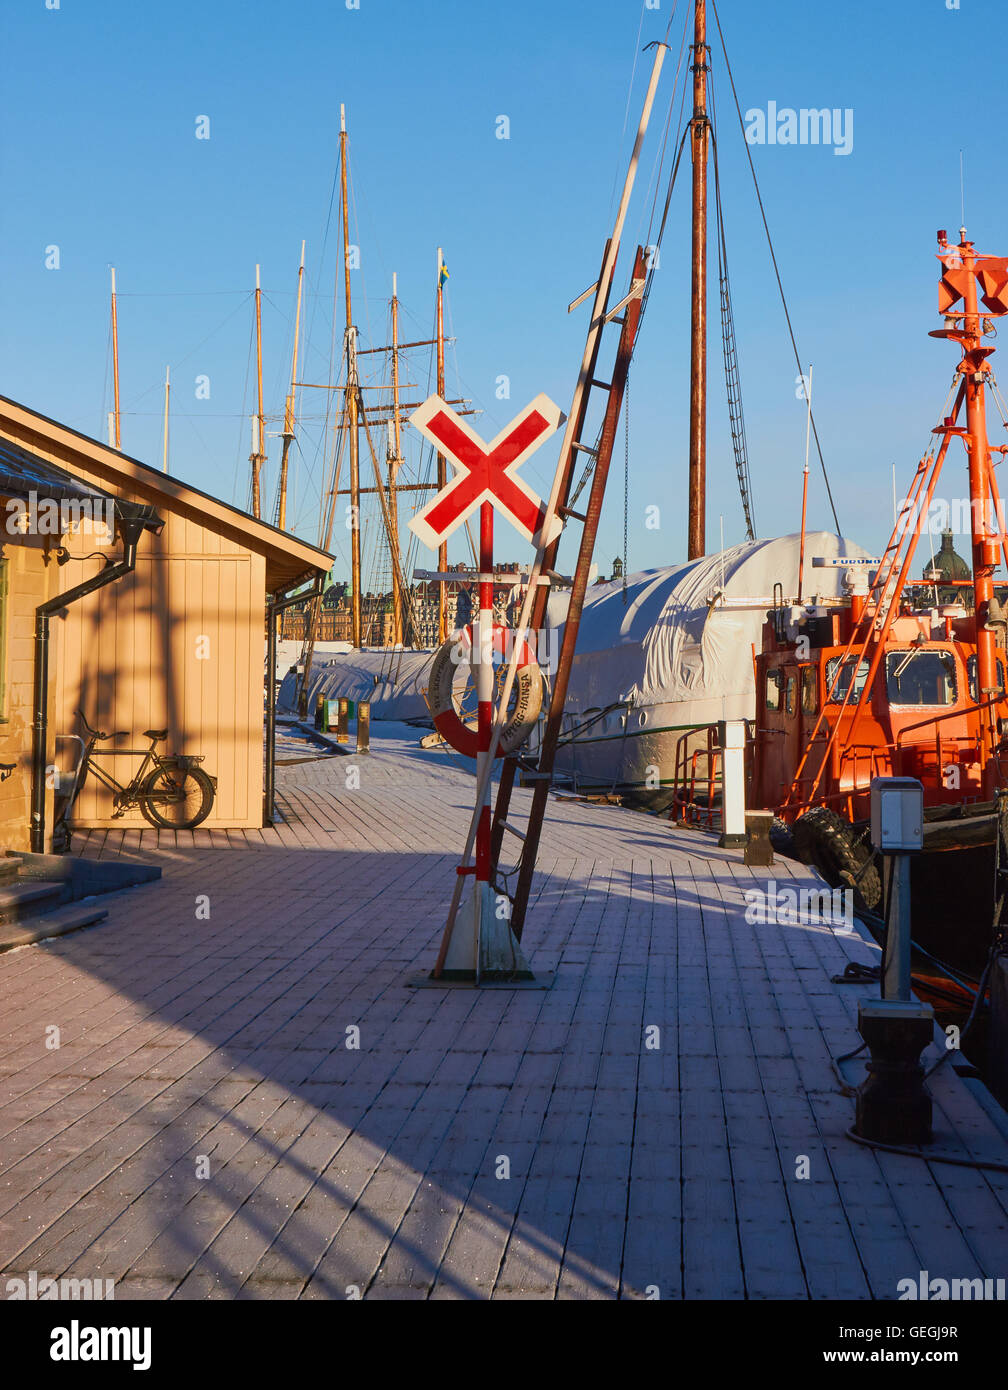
[0,0,1008,587]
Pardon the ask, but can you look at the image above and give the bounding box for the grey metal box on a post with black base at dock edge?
[854,777,934,1144]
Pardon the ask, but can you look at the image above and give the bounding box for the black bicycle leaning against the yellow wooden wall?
[53,710,217,847]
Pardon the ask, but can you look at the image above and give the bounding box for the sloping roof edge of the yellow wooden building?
[0,396,334,594]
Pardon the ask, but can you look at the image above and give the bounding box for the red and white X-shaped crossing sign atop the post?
[410,395,566,550]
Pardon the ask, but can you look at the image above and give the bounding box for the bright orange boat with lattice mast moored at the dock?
[749,228,1008,970]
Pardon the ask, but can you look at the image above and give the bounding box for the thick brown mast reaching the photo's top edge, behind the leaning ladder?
[687,0,708,560]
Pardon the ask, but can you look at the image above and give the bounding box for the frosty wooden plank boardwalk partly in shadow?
[0,726,1008,1300]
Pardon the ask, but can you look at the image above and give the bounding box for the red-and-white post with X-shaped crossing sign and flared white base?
[410,395,564,984]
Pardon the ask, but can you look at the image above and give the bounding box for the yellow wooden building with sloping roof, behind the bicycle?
[0,398,332,848]
